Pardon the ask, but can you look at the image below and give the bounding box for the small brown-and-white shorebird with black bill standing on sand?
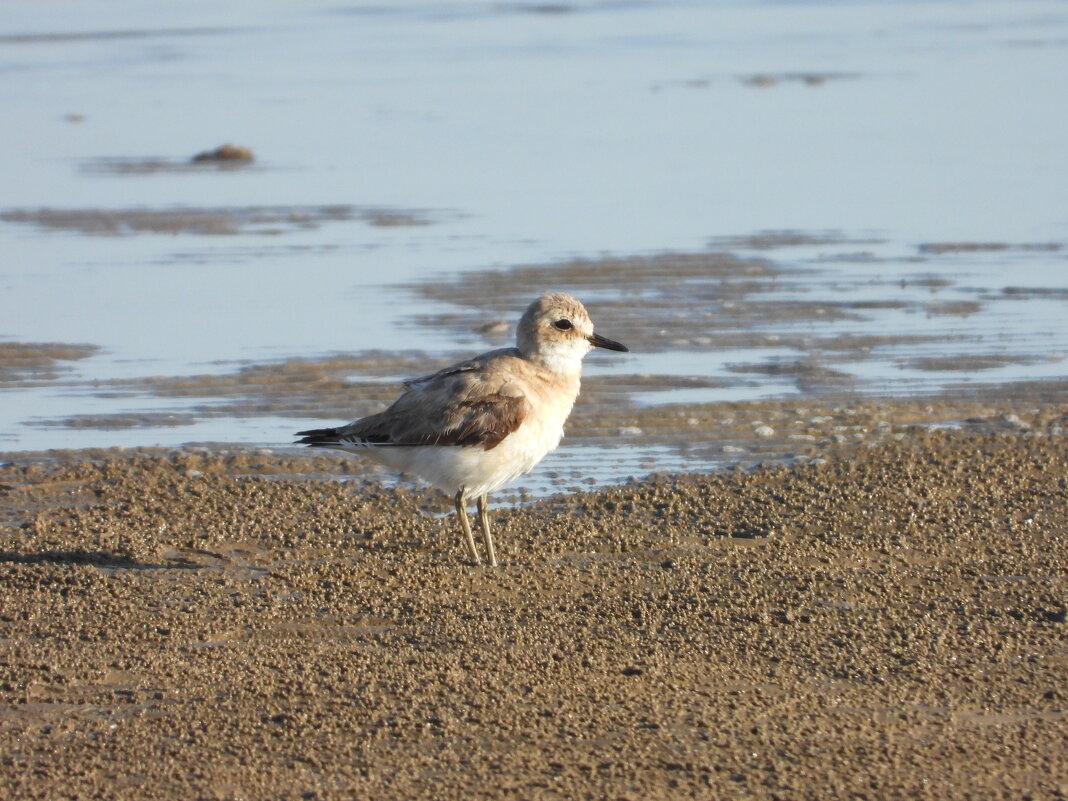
[297,293,627,567]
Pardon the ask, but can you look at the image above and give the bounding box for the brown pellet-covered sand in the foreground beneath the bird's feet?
[0,425,1068,800]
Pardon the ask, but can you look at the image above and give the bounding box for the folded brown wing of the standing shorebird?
[337,356,528,451]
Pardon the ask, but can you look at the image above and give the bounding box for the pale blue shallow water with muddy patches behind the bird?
[0,1,1068,489]
